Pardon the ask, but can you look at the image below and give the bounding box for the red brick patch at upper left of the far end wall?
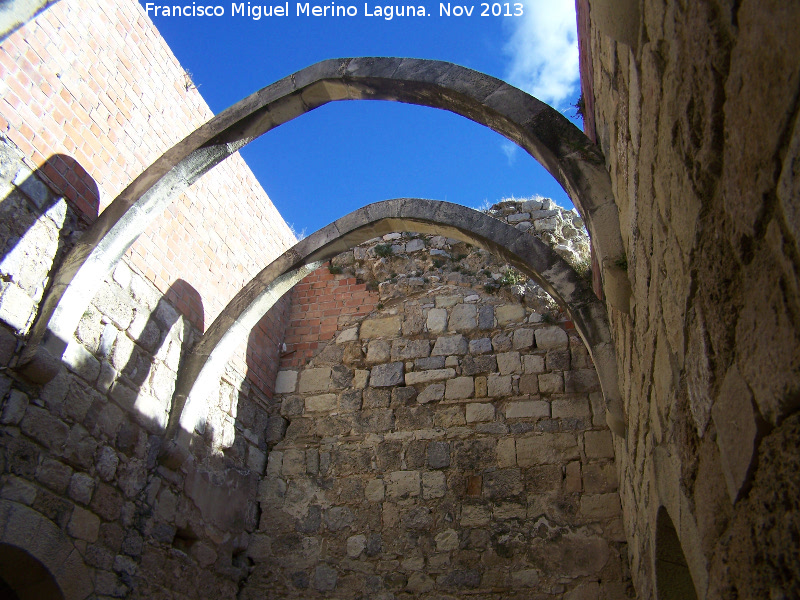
[280,266,380,369]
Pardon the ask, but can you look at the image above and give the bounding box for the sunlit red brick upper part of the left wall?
[0,0,294,398]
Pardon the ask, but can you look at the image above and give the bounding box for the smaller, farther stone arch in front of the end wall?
[161,198,624,461]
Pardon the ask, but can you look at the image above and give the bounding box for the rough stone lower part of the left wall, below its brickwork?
[0,130,286,598]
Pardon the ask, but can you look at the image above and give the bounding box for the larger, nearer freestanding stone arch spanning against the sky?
[20,58,630,380]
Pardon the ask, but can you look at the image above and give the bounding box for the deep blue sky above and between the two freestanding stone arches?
[141,0,580,233]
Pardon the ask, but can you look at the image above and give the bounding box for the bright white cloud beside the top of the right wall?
[504,0,580,110]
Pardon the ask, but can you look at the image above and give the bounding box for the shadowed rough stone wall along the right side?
[583,0,800,598]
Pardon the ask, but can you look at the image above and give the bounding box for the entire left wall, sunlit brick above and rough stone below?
[0,0,294,598]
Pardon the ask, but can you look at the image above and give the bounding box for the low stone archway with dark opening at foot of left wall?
[0,500,94,600]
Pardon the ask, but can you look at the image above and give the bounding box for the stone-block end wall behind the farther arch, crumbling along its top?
[247,200,629,599]
